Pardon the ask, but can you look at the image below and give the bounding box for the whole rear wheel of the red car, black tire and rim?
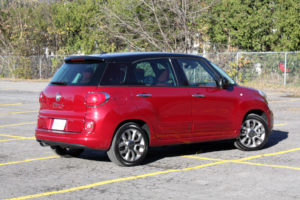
[107,122,149,167]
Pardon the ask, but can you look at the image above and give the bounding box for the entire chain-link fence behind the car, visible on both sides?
[0,52,300,86]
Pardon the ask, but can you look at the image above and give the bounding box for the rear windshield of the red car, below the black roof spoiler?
[50,62,106,86]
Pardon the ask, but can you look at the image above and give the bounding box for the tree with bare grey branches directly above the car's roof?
[104,0,214,52]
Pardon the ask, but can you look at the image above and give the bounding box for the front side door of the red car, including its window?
[177,58,238,139]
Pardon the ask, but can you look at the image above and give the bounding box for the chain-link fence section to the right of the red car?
[202,52,300,86]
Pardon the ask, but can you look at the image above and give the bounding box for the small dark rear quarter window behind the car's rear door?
[101,63,128,85]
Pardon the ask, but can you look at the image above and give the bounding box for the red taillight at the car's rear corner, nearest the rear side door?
[85,92,110,107]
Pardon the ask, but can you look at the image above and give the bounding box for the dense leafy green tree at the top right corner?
[205,0,300,51]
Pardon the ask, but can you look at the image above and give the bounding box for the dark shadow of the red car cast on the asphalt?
[77,130,288,165]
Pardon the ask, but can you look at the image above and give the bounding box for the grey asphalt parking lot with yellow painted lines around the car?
[0,80,300,200]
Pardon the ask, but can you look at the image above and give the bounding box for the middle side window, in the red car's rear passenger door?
[131,59,176,87]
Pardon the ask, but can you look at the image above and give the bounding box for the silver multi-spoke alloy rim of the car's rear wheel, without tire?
[118,128,146,162]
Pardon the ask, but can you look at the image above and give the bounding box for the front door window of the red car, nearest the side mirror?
[177,58,217,87]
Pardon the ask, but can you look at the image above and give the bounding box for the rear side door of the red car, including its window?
[130,58,192,140]
